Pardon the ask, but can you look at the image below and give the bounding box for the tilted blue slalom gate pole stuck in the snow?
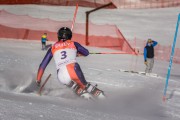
[163,14,180,101]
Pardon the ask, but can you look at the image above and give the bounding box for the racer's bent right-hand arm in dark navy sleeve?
[74,42,89,56]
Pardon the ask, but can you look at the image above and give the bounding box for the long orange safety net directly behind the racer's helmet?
[0,10,134,54]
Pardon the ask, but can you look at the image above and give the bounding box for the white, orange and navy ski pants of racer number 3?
[57,63,87,89]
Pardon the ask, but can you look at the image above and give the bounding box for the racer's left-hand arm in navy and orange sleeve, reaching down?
[37,48,53,82]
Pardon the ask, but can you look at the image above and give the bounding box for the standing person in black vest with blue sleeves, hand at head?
[144,39,158,73]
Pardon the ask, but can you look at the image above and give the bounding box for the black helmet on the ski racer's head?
[58,27,72,41]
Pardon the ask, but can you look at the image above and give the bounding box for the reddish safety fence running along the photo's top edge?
[0,0,180,8]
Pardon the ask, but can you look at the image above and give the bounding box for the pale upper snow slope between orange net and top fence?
[0,5,180,48]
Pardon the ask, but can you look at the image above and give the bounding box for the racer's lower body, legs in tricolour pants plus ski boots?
[58,63,104,99]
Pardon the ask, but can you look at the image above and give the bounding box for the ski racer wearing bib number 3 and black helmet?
[36,27,105,99]
